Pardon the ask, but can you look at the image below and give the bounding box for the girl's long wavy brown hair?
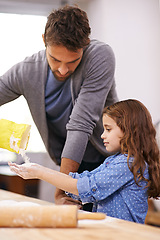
[103,99,160,198]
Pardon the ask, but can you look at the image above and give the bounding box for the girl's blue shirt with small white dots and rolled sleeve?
[69,153,149,223]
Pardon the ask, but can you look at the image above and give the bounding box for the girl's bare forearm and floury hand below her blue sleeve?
[8,162,79,195]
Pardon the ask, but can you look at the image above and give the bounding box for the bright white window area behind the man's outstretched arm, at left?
[0,13,46,152]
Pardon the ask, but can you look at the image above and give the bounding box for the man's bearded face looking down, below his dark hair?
[46,45,83,81]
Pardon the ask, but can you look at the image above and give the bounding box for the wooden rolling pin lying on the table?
[0,205,106,228]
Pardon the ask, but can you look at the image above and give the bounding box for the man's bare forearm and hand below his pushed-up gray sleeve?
[55,158,82,208]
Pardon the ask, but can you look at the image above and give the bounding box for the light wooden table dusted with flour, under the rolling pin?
[0,190,160,240]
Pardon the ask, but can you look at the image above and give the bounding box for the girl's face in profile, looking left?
[101,114,124,153]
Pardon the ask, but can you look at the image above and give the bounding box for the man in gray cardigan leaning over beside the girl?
[0,6,118,208]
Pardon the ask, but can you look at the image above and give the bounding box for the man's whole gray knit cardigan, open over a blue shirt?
[0,40,118,165]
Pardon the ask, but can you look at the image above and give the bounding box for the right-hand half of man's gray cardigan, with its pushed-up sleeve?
[62,41,117,163]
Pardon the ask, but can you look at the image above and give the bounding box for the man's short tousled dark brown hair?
[44,6,91,51]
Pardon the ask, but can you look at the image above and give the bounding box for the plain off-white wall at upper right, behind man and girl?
[85,0,160,122]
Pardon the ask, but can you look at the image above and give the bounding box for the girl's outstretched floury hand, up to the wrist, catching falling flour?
[8,162,42,179]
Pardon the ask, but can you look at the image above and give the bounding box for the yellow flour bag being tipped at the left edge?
[0,119,31,154]
